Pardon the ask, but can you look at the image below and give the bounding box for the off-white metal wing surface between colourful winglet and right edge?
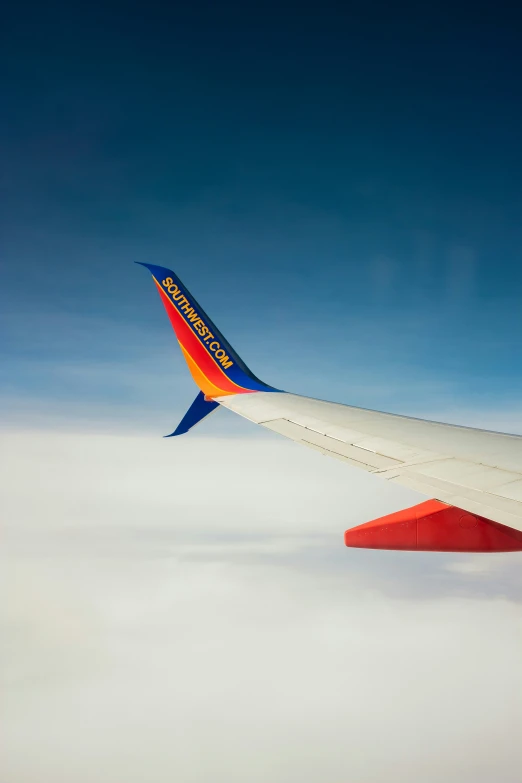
[217,392,522,531]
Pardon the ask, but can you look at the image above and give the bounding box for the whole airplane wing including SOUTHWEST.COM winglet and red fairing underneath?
[137,264,522,551]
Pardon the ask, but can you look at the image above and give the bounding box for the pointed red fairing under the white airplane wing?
[344,500,522,552]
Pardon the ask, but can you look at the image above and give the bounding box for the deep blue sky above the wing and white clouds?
[0,3,522,434]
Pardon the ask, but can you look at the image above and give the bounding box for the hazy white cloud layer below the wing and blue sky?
[0,430,522,783]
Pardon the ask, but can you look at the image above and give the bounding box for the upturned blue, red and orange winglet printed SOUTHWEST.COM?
[137,262,278,398]
